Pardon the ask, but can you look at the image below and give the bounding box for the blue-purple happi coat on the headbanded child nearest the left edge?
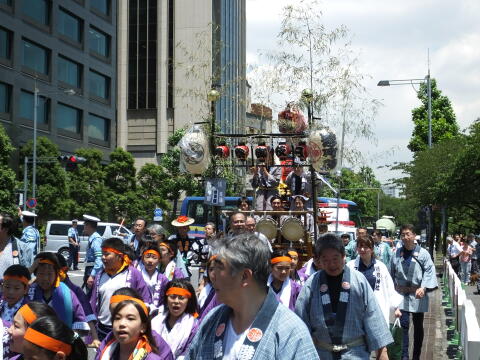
[28,282,90,331]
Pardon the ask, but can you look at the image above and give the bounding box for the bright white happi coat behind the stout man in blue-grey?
[347,256,403,324]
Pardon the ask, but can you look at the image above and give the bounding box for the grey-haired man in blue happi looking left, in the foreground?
[186,233,318,360]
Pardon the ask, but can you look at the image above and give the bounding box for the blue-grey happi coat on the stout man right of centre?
[295,267,393,360]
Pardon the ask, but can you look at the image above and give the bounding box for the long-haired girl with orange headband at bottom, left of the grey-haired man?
[95,287,173,360]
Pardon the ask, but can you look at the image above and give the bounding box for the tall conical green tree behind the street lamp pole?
[408,79,459,153]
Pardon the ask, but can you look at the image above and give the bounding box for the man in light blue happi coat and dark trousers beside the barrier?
[390,224,437,360]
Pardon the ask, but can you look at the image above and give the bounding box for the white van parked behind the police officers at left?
[43,220,132,261]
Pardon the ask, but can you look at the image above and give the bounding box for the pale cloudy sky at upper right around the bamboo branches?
[246,0,480,183]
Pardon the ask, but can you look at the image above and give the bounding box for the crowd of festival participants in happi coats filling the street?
[0,205,437,360]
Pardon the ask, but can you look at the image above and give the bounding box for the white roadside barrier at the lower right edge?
[443,260,480,360]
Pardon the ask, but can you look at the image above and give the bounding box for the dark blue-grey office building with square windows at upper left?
[0,0,117,165]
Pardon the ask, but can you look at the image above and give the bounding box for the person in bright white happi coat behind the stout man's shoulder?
[347,235,403,324]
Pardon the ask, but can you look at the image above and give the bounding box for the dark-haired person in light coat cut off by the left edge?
[0,213,23,280]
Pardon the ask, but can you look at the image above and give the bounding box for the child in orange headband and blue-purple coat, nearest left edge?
[28,252,90,334]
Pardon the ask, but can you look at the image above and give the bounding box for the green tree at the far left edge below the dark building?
[0,124,17,213]
